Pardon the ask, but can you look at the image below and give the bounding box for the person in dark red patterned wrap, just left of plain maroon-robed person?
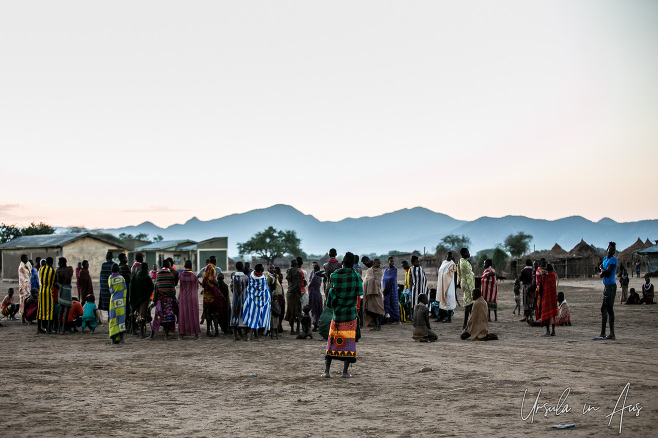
[149,260,178,340]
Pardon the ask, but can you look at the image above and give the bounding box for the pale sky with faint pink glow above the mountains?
[0,0,658,228]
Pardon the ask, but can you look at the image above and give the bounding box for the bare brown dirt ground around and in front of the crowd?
[0,279,658,437]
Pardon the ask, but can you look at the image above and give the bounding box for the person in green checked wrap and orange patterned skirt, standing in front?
[322,252,363,378]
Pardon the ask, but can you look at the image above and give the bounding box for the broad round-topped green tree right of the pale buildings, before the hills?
[237,226,302,264]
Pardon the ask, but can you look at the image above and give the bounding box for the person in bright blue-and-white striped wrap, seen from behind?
[242,263,272,341]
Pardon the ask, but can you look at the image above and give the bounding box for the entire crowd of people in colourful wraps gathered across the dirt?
[0,242,653,377]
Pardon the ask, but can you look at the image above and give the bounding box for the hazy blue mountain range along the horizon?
[78,204,658,255]
